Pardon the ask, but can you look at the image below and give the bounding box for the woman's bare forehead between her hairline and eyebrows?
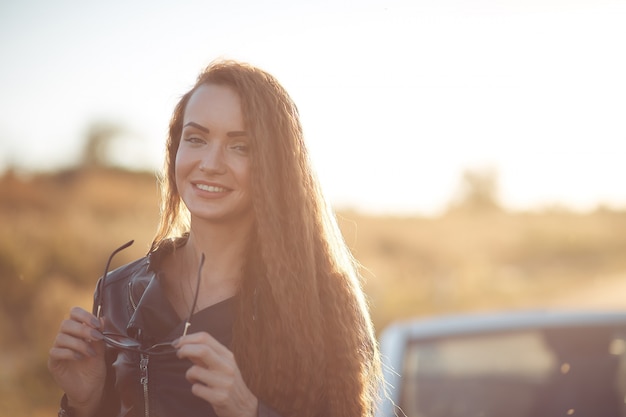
[183,84,243,127]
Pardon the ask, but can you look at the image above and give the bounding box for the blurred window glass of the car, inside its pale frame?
[400,327,626,417]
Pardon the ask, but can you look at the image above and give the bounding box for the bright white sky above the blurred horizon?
[0,0,626,214]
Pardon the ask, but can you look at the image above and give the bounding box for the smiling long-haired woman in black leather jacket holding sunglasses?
[49,61,380,417]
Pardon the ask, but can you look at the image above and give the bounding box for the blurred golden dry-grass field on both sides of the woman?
[0,169,626,417]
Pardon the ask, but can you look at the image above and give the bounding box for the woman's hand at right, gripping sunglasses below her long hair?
[174,332,258,417]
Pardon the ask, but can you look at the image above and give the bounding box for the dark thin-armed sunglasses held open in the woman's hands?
[96,240,204,355]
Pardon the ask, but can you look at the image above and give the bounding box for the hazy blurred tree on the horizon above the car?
[450,168,501,212]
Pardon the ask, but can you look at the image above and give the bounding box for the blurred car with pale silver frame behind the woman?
[377,311,626,417]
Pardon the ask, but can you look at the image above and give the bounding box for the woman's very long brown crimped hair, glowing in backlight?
[151,60,381,417]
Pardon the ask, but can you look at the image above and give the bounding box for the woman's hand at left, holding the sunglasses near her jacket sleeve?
[48,307,106,415]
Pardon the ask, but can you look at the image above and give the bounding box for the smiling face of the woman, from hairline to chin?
[175,84,253,226]
